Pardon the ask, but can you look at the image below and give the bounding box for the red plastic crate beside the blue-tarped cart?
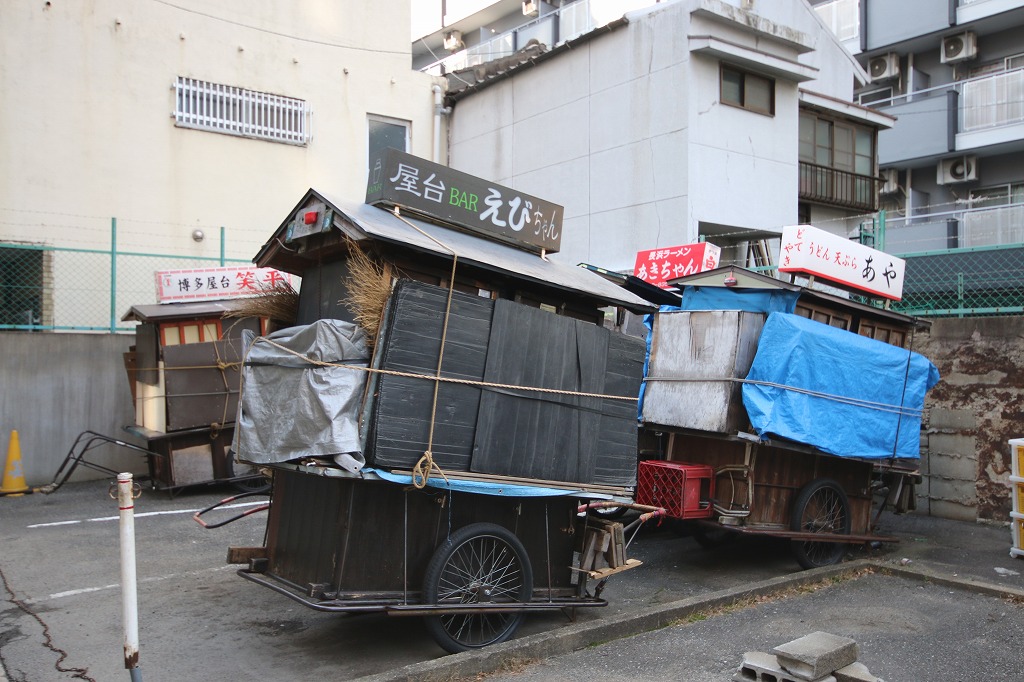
[636,460,715,518]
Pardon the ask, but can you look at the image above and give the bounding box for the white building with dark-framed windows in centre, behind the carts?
[414,0,892,271]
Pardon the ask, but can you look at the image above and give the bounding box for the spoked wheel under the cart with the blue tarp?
[790,478,850,568]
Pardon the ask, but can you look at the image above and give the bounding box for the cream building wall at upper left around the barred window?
[0,0,444,261]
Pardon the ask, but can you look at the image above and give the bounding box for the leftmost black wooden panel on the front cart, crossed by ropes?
[367,281,494,471]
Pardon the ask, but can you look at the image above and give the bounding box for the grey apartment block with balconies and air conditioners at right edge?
[814,0,1024,314]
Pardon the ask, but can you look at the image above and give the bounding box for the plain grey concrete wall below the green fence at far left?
[0,332,146,486]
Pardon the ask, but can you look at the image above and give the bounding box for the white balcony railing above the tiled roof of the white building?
[420,0,659,76]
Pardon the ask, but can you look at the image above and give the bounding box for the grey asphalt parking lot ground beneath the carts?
[0,481,1024,682]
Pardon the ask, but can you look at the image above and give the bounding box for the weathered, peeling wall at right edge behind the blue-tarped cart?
[913,316,1024,521]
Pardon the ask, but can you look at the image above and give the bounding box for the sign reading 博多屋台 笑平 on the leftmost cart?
[157,265,292,303]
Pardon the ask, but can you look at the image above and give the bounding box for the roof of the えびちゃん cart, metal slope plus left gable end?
[253,189,656,312]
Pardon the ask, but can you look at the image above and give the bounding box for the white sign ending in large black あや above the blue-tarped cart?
[778,225,906,301]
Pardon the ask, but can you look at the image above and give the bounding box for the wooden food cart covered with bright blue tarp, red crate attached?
[636,254,938,567]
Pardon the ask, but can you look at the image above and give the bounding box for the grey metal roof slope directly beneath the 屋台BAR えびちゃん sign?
[314,188,655,311]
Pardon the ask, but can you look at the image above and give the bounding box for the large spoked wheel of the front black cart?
[423,523,534,653]
